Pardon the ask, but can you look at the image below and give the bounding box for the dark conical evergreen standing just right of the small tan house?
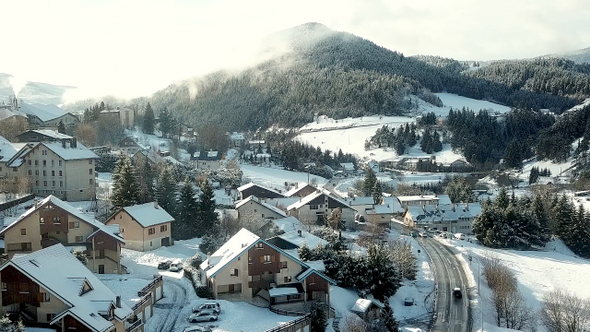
[172,178,200,240]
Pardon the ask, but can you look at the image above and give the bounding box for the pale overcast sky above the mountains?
[0,0,590,97]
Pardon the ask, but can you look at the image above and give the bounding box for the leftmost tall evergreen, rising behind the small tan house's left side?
[111,154,139,209]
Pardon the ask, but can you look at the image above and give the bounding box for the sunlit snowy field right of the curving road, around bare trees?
[440,239,590,332]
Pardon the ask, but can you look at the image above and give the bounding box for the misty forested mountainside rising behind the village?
[134,23,590,130]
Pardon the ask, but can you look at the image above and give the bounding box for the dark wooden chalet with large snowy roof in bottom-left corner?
[0,244,143,332]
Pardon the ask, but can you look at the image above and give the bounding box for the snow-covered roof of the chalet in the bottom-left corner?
[0,244,133,332]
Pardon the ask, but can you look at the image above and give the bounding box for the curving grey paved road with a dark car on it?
[419,238,471,332]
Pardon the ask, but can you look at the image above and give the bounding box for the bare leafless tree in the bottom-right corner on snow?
[540,290,590,332]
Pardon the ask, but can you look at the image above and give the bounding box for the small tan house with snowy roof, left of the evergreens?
[106,202,174,251]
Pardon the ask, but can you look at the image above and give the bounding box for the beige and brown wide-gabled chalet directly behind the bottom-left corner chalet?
[0,195,125,274]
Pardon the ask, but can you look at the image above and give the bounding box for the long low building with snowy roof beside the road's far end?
[404,203,481,234]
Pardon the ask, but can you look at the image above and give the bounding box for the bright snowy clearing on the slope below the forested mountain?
[298,93,510,163]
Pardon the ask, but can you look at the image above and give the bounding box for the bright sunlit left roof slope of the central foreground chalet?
[201,228,260,278]
